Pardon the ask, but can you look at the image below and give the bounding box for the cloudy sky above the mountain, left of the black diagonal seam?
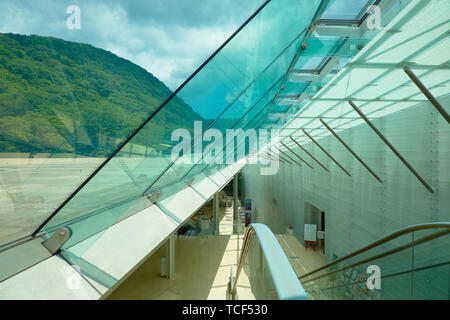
[0,0,263,90]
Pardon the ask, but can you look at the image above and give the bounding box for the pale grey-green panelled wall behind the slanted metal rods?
[242,96,450,298]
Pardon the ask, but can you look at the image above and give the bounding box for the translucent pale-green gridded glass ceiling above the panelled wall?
[282,1,450,149]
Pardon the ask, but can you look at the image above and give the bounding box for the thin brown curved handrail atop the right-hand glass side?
[299,222,450,282]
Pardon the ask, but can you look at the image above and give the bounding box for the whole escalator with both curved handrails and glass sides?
[227,222,450,300]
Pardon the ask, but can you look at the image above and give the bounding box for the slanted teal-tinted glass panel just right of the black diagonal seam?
[37,0,326,248]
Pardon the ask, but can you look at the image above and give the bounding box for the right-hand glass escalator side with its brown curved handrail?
[299,222,450,300]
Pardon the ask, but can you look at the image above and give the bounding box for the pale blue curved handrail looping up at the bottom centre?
[232,223,307,300]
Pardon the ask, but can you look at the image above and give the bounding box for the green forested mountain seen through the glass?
[0,33,202,156]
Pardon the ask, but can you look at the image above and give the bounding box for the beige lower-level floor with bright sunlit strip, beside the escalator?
[108,206,324,300]
